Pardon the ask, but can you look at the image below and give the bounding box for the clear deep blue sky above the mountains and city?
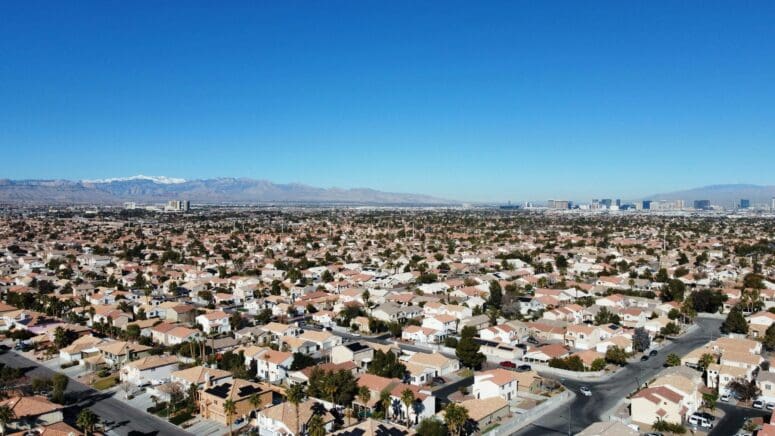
[0,0,775,201]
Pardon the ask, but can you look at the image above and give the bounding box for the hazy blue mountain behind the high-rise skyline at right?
[646,184,775,207]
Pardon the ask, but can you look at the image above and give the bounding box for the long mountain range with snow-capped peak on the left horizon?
[0,175,457,205]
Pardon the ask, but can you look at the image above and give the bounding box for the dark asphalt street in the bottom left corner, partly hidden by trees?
[0,351,190,436]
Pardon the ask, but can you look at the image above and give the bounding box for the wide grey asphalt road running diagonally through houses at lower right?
[516,318,722,436]
